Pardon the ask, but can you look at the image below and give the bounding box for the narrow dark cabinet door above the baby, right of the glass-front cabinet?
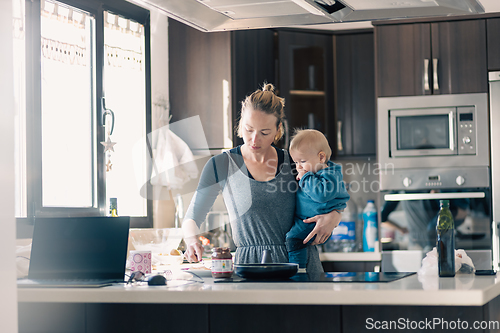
[336,32,376,157]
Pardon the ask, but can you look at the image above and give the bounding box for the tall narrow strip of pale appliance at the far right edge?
[489,72,500,270]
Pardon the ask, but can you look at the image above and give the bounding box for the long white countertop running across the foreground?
[18,273,500,306]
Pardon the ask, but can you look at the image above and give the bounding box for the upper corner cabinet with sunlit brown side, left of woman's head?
[168,20,275,147]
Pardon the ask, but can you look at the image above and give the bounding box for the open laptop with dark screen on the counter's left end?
[17,217,130,288]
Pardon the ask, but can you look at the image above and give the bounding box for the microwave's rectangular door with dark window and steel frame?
[389,108,457,157]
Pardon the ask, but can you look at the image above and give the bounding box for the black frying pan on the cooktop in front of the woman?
[234,250,299,279]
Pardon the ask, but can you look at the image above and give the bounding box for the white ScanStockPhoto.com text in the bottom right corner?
[365,318,500,332]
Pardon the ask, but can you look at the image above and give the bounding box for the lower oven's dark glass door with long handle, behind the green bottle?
[381,188,492,253]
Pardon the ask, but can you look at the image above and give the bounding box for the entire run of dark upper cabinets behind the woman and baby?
[169,20,375,158]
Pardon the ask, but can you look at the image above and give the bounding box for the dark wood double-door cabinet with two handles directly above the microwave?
[375,20,488,97]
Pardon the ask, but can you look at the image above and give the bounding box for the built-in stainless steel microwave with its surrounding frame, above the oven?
[377,94,489,168]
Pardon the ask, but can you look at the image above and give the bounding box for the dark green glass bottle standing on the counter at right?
[436,200,455,277]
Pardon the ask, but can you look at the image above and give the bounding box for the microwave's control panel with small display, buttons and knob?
[457,106,476,155]
